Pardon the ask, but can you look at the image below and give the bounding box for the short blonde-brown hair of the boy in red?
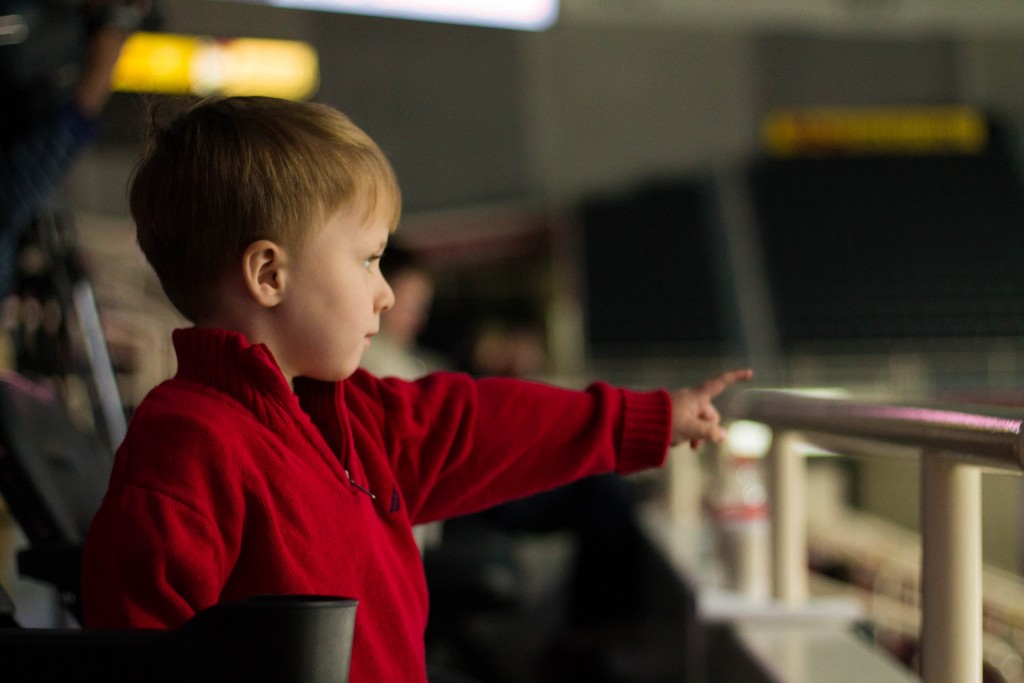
[129,97,401,323]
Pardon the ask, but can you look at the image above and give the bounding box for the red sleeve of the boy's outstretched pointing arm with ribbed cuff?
[346,373,671,523]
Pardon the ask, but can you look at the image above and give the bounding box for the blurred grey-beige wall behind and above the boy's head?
[75,0,1024,212]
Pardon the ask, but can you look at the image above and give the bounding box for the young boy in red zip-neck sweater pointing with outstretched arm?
[83,98,750,682]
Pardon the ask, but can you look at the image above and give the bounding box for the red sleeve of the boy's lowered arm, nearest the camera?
[82,409,244,629]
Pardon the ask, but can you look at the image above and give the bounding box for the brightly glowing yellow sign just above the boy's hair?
[113,32,319,99]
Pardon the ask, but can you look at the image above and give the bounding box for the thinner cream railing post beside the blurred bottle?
[768,431,808,605]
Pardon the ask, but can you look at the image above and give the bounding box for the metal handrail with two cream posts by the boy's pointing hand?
[724,390,1024,683]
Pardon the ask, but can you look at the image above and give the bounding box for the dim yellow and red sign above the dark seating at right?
[761,105,988,157]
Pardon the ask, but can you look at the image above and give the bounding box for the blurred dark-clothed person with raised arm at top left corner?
[0,0,150,295]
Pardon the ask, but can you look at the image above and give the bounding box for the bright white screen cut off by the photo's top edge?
[253,0,558,31]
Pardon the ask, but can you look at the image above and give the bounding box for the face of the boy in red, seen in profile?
[273,208,394,381]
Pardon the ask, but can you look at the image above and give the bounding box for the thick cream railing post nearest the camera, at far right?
[921,451,982,683]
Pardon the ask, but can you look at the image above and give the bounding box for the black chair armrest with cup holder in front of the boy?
[0,595,357,683]
